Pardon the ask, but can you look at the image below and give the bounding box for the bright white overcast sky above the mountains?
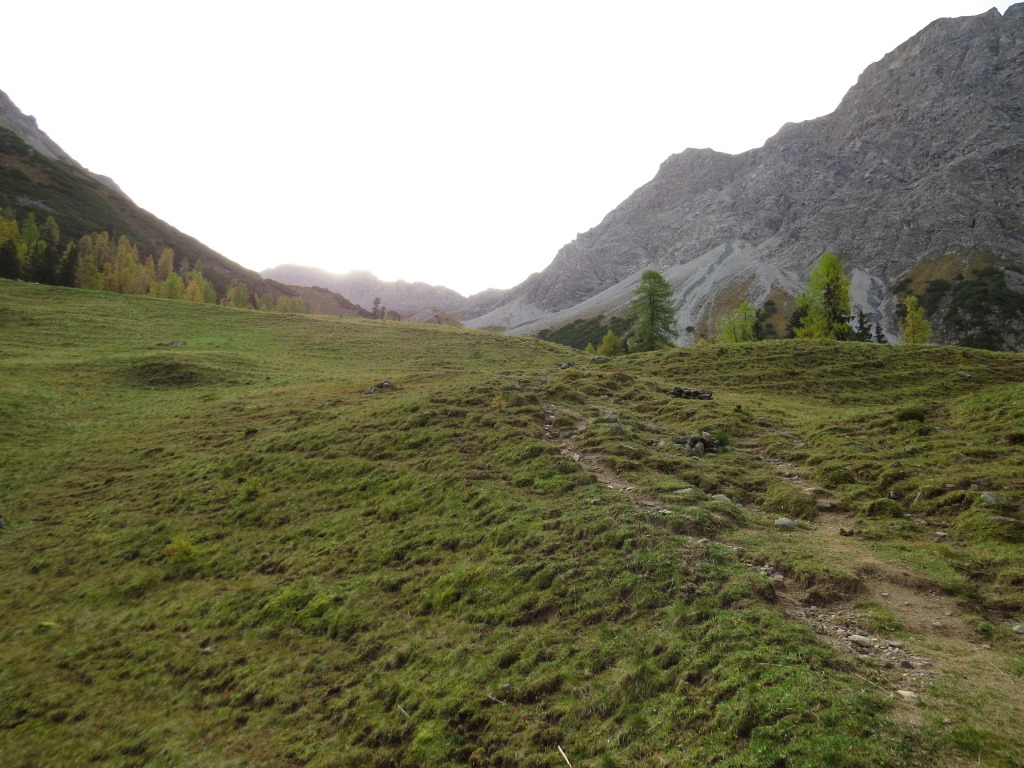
[0,0,1009,295]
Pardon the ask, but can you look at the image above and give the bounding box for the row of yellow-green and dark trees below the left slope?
[0,211,309,313]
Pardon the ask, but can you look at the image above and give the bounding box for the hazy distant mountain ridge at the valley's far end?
[260,264,467,313]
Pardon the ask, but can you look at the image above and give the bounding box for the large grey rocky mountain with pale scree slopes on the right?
[462,3,1024,348]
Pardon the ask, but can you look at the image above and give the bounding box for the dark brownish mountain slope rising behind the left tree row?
[0,84,295,296]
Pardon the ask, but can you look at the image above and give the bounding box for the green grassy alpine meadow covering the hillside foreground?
[0,281,1024,768]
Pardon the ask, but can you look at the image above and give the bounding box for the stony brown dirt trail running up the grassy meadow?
[544,403,1024,722]
